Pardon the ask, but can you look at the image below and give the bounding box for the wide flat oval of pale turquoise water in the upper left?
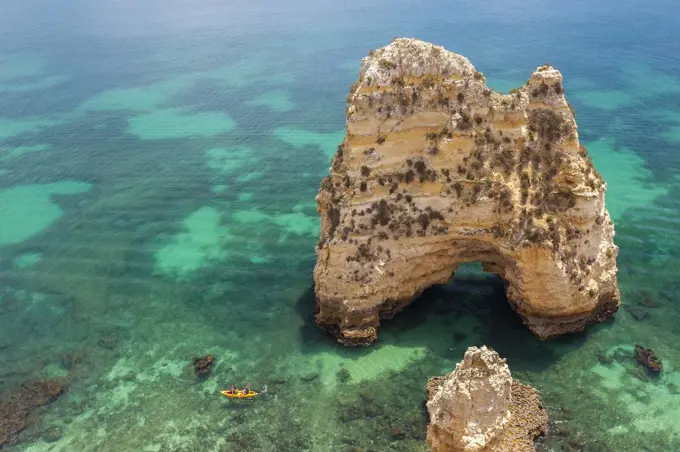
[128,108,236,140]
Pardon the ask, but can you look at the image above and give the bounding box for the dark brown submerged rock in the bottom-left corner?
[0,380,66,448]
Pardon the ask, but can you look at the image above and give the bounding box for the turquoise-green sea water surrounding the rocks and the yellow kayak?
[0,0,680,452]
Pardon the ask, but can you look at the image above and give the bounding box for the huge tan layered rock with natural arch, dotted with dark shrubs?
[314,39,619,345]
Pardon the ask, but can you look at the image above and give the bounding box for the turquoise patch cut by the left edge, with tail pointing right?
[0,181,91,246]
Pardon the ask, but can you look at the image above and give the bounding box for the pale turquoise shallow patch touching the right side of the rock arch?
[586,140,668,220]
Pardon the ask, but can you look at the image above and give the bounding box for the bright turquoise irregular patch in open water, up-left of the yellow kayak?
[155,206,232,281]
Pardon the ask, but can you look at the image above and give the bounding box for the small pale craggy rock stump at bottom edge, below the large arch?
[427,346,548,452]
